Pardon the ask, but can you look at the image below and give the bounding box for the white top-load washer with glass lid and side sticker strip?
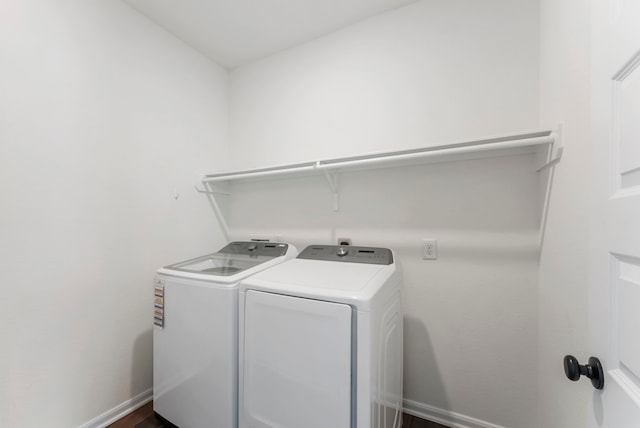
[153,242,297,428]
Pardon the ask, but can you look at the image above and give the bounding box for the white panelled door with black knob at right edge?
[592,0,640,428]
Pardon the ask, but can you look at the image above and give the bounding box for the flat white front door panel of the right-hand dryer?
[240,290,352,428]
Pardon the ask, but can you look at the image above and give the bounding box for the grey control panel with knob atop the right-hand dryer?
[298,245,393,265]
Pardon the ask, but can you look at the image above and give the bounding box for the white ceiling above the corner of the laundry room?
[124,0,417,68]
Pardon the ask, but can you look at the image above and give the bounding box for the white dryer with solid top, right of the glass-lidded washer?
[239,245,403,428]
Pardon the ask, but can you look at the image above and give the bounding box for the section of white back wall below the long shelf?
[229,155,538,428]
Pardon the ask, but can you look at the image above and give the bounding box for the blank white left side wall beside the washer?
[0,0,228,428]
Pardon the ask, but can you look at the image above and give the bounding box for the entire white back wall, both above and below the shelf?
[229,0,540,428]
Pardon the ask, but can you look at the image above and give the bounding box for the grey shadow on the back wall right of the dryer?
[403,316,452,417]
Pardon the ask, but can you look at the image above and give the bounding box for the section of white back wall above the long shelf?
[231,0,538,167]
